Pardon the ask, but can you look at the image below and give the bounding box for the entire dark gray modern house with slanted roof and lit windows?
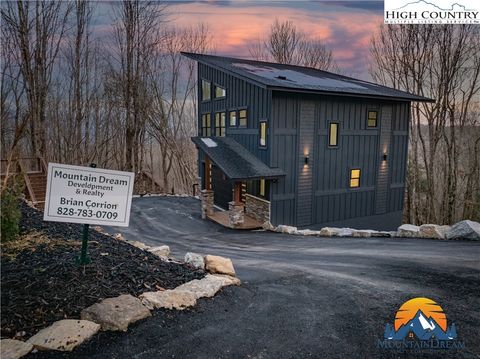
[184,53,432,230]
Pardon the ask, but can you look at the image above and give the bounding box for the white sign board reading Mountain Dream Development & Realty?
[43,163,135,227]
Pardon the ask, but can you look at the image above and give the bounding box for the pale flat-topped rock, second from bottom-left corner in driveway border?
[27,319,100,351]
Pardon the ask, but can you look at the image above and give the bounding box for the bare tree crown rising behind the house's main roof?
[249,19,337,71]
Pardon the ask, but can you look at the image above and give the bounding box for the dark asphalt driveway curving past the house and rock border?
[31,197,480,358]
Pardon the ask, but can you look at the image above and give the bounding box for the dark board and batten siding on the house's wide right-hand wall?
[272,93,409,226]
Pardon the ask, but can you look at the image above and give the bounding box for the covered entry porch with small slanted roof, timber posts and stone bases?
[192,137,285,229]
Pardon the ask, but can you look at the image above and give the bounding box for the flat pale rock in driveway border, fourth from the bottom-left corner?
[139,289,197,310]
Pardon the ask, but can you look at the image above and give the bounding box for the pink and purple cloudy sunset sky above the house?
[96,0,383,79]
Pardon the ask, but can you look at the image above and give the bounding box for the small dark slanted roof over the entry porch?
[192,137,285,181]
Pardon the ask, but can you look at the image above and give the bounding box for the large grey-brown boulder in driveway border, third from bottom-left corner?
[81,294,151,331]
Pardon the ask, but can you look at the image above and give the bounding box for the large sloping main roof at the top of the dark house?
[182,52,434,102]
